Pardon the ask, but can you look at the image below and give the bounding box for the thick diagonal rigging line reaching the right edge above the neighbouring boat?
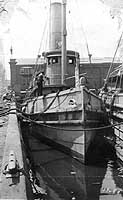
[103,31,123,88]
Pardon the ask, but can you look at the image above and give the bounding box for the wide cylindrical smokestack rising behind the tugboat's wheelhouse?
[49,1,62,51]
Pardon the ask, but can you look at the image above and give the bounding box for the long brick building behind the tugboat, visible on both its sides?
[9,58,121,95]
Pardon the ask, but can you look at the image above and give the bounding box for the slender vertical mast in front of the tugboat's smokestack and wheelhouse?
[61,0,67,85]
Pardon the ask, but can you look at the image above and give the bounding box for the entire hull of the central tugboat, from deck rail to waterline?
[23,88,106,163]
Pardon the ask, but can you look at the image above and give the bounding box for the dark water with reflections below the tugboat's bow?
[26,132,123,200]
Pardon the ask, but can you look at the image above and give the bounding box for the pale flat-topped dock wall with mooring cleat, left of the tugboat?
[0,104,32,200]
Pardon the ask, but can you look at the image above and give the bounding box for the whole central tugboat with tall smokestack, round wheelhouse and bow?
[22,0,108,163]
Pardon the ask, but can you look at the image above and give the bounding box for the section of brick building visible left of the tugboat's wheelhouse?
[9,58,45,95]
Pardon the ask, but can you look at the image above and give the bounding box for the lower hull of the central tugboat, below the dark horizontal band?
[28,119,96,162]
